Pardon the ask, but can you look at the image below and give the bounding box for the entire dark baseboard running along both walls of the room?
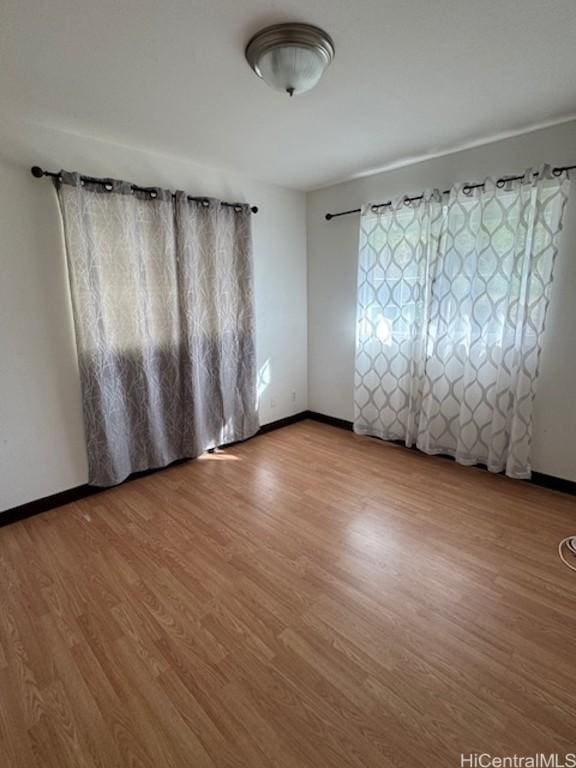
[0,411,576,528]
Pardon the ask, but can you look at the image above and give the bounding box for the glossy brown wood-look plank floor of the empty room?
[0,421,576,768]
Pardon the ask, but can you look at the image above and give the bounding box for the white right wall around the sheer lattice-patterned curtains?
[308,122,576,480]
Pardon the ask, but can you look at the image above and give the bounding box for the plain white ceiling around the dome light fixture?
[0,0,576,189]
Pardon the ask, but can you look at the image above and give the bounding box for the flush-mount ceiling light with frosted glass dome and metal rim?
[246,24,334,96]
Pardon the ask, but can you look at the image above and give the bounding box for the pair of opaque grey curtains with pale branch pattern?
[56,171,258,486]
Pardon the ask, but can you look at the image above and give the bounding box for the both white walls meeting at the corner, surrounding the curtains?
[0,120,576,510]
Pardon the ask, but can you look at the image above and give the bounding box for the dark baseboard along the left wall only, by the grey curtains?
[0,411,307,528]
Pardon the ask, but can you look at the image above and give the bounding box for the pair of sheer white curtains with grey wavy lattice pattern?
[354,167,570,478]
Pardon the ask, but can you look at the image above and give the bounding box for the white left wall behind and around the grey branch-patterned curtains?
[0,121,307,510]
